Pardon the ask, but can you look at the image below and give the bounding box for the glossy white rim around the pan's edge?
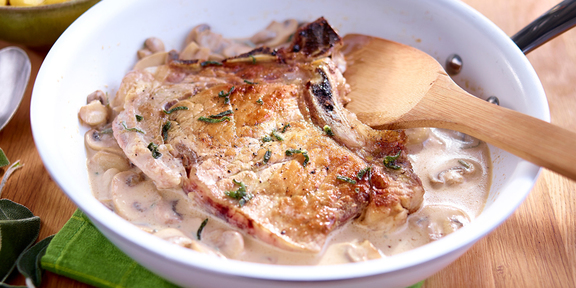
[30,0,550,281]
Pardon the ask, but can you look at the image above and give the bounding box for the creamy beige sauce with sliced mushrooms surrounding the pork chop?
[79,20,492,265]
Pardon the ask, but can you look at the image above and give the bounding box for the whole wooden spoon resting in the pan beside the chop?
[344,34,576,180]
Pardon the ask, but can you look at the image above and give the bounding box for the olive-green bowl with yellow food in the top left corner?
[0,0,99,48]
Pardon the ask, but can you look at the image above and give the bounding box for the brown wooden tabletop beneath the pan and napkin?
[0,0,576,288]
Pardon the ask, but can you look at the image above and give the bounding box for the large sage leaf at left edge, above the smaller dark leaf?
[0,199,40,282]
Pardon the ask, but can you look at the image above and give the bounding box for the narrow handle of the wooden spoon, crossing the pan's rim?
[414,76,576,180]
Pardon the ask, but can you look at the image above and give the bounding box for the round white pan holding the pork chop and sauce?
[31,0,550,287]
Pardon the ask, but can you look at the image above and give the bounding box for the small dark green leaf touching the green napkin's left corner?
[16,235,54,287]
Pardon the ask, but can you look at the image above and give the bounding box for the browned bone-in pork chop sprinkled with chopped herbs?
[113,18,423,252]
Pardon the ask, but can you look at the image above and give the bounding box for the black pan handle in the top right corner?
[512,0,576,54]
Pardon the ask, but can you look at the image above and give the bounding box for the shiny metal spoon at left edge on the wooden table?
[0,47,31,130]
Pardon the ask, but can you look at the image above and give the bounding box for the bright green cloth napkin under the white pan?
[41,210,424,288]
